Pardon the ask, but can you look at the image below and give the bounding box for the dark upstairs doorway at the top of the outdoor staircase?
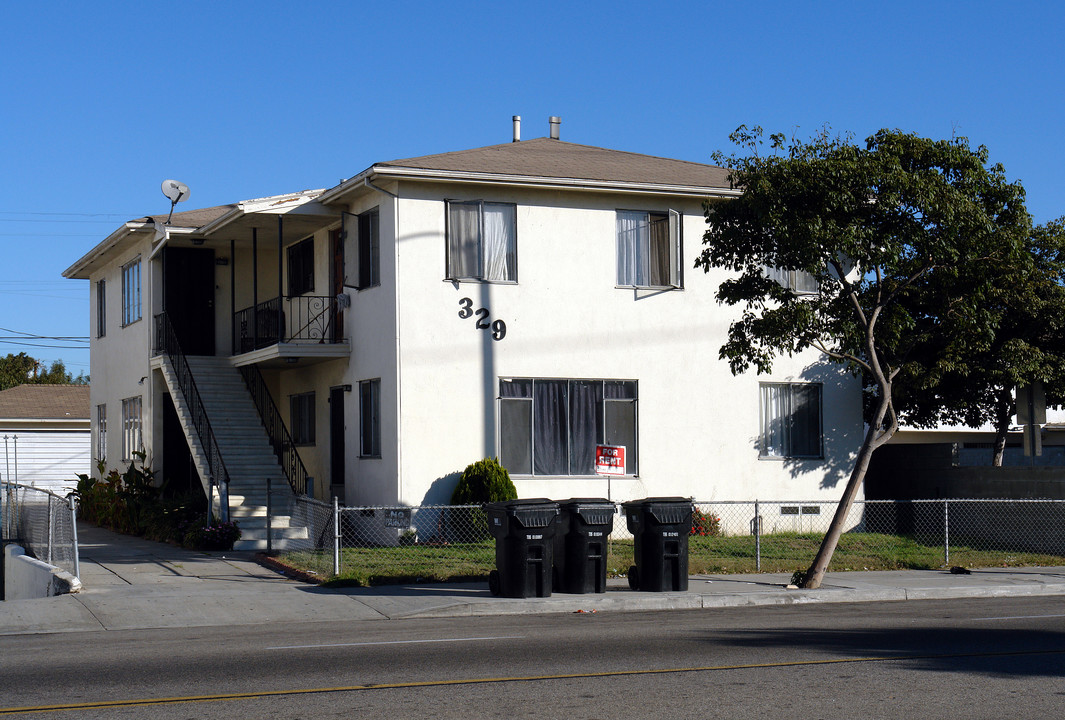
[163,246,214,355]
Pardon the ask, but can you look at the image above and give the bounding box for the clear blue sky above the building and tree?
[0,0,1065,374]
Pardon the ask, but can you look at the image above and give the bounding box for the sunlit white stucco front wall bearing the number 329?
[382,183,862,504]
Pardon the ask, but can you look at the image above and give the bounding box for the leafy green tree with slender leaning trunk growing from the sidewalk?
[697,127,1031,588]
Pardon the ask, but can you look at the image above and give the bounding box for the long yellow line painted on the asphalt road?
[0,650,1065,715]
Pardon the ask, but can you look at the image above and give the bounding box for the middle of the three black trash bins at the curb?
[555,497,618,593]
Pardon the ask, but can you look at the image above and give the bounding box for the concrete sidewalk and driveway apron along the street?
[0,524,1065,635]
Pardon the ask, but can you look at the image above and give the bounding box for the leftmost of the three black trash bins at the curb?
[485,497,558,598]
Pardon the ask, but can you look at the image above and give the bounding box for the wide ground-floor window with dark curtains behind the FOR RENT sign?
[499,378,637,475]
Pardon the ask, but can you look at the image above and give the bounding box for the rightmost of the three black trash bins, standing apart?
[622,497,694,592]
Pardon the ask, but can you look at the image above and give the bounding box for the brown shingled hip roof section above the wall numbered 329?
[375,137,730,189]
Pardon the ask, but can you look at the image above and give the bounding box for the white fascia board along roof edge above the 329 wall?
[368,166,743,197]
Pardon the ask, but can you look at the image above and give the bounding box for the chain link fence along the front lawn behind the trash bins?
[272,497,1065,584]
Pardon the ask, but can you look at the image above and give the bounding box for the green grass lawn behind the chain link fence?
[280,533,1065,587]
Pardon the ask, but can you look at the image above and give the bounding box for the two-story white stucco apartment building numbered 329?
[64,122,863,545]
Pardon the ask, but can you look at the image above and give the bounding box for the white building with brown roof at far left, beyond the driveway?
[0,384,92,495]
